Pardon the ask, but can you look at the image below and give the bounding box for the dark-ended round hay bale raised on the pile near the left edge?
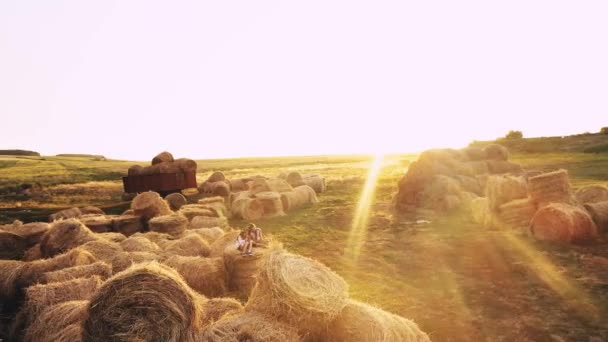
[40,219,97,258]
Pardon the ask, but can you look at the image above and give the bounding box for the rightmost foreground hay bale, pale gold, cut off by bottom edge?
[322,299,431,342]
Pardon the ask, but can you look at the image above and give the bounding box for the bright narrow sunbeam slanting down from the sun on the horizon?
[346,154,384,261]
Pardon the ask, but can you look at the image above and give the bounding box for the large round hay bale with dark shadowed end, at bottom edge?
[83,263,203,342]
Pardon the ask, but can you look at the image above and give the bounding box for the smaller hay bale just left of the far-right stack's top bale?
[486,175,528,211]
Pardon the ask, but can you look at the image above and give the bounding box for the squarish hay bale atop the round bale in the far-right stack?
[528,170,572,207]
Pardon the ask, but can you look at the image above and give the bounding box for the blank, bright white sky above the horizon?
[0,0,608,160]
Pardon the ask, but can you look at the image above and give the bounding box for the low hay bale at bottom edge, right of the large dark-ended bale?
[203,312,302,342]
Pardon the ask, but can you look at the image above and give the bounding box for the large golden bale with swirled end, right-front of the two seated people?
[245,251,348,333]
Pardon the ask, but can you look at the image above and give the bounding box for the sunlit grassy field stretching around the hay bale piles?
[0,153,608,341]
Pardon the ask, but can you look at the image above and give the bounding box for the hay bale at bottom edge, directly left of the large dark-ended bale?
[23,300,89,342]
